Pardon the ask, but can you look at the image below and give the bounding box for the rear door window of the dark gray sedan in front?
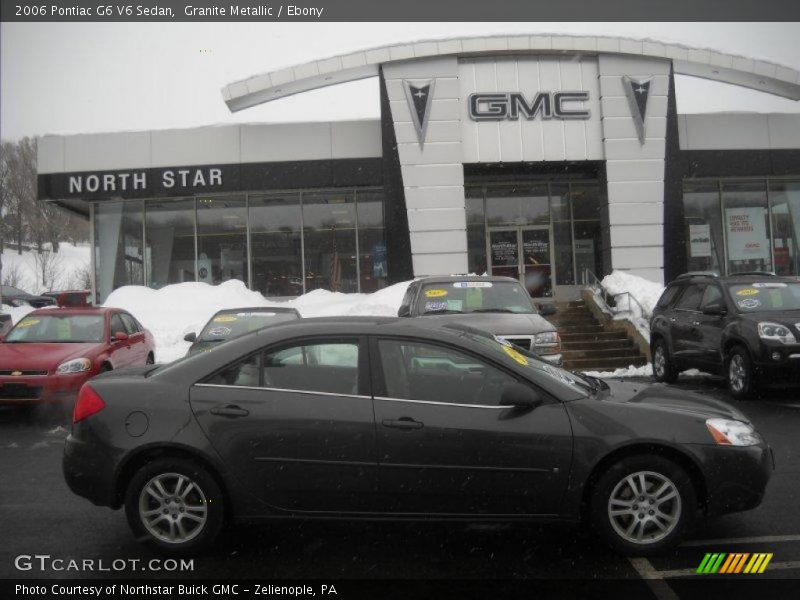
[263,339,359,394]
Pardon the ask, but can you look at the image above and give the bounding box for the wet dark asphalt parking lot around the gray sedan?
[0,377,800,598]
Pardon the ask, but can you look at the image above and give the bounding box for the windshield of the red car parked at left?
[5,315,103,344]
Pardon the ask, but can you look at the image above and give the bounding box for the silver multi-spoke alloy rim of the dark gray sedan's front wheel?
[608,471,682,545]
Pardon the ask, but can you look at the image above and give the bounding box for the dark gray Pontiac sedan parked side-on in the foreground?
[64,317,773,555]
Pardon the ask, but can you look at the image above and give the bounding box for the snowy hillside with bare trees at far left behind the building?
[2,243,91,294]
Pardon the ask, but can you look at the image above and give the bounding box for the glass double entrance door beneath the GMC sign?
[487,226,553,298]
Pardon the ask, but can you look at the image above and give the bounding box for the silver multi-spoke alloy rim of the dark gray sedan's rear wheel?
[139,473,208,544]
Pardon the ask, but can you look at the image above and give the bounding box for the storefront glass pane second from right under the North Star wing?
[303,191,358,293]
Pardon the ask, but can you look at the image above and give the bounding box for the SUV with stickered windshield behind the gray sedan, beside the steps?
[397,276,562,365]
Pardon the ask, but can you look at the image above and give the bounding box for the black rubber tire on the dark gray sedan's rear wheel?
[125,457,225,555]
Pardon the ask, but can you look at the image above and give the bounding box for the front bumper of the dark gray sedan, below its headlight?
[693,443,775,516]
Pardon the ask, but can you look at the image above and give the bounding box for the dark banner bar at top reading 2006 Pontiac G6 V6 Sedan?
[1,0,800,22]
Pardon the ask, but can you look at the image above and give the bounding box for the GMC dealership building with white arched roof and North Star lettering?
[38,35,800,301]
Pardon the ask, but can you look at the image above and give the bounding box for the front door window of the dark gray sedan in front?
[378,340,516,406]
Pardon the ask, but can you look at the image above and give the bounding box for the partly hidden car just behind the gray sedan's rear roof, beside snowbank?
[183,306,300,355]
